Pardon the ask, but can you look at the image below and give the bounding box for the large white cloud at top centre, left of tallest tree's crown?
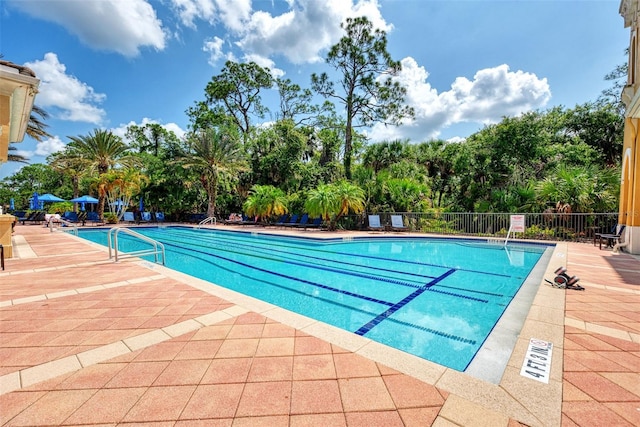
[182,0,393,67]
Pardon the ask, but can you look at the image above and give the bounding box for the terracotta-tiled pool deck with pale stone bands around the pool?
[0,225,640,427]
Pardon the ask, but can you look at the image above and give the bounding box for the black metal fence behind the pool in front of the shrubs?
[338,212,618,241]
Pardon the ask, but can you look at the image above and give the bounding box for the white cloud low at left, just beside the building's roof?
[25,52,106,124]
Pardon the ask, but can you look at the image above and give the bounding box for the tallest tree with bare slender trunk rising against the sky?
[311,17,414,179]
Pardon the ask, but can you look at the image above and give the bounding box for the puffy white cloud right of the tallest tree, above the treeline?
[369,57,551,141]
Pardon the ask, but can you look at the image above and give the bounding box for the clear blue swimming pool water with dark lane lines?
[79,227,546,371]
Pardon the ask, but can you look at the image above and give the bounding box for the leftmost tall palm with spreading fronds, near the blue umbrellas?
[67,129,139,218]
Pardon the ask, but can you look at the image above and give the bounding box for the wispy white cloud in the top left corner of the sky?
[11,0,167,57]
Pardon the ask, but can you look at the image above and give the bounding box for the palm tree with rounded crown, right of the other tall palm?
[178,128,246,217]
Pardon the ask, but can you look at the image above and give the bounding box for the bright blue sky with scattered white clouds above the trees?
[0,0,629,178]
